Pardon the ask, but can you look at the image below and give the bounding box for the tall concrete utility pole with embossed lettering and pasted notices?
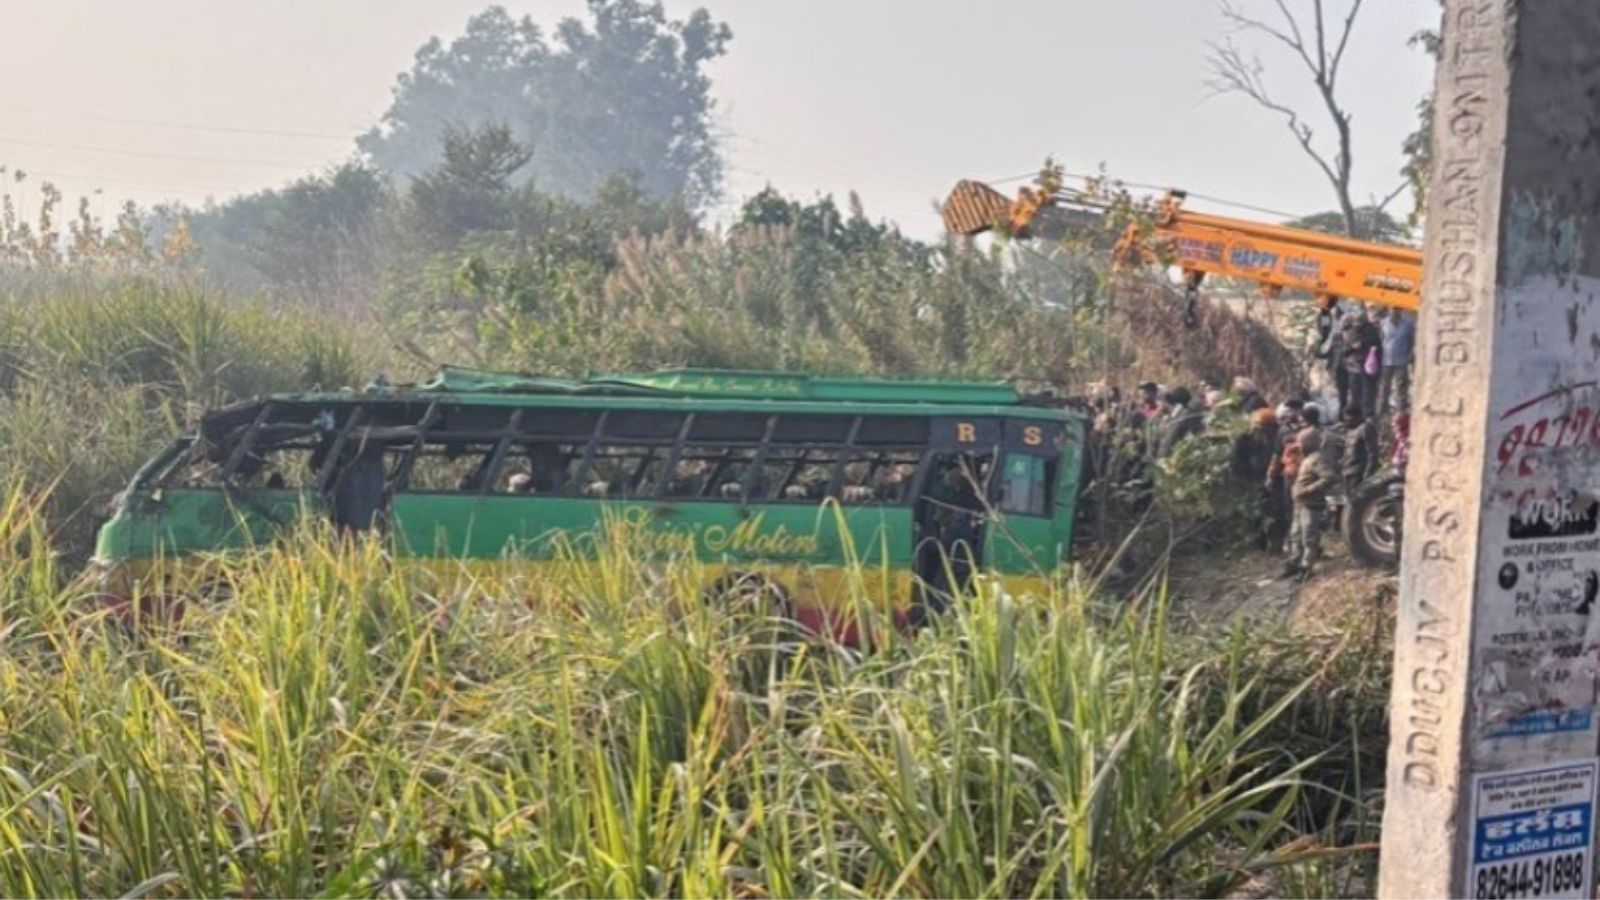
[1378,0,1600,897]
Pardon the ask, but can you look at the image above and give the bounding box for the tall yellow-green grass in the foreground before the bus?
[0,493,1369,897]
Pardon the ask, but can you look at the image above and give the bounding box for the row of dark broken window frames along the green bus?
[165,397,1075,517]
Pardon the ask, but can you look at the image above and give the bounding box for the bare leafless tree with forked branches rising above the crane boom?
[1206,0,1405,237]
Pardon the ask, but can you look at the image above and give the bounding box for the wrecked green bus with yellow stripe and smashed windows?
[96,368,1085,633]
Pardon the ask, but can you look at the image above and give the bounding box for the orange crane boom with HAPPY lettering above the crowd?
[944,181,1422,311]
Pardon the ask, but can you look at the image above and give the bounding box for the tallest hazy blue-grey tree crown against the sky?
[357,0,731,207]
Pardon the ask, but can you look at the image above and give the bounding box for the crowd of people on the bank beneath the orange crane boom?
[1086,301,1416,580]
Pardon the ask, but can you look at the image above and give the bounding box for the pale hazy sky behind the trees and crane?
[0,0,1438,235]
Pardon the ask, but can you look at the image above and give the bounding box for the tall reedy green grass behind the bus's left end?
[0,274,373,560]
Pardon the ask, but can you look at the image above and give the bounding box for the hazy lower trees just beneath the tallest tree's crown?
[187,125,696,312]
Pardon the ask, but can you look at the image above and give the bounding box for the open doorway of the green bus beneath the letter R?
[912,416,1002,612]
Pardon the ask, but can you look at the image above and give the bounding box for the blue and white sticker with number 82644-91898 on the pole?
[1467,761,1597,897]
